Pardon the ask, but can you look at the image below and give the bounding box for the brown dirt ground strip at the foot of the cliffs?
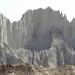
[0,64,75,75]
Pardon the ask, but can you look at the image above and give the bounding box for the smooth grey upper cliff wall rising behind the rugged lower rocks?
[0,7,72,50]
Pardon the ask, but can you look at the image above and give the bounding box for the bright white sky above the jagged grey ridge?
[0,0,75,22]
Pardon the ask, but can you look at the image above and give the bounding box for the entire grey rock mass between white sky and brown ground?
[0,7,75,66]
